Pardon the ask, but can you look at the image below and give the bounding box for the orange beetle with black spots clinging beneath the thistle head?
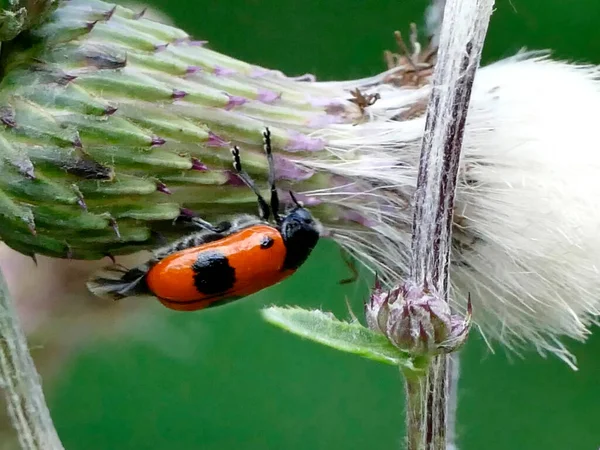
[87,128,320,311]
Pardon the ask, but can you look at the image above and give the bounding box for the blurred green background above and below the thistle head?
[50,0,600,450]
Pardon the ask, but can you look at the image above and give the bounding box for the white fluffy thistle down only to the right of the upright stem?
[454,53,600,366]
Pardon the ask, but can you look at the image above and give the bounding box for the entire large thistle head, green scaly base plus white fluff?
[0,0,600,361]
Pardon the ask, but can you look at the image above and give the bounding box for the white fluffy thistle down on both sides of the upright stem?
[302,53,600,370]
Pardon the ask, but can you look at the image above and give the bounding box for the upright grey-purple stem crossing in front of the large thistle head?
[407,0,494,450]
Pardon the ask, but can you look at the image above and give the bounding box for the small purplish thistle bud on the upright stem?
[365,282,471,356]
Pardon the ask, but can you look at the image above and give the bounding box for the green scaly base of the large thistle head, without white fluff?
[0,0,414,268]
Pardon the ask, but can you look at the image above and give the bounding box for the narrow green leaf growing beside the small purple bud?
[262,306,413,369]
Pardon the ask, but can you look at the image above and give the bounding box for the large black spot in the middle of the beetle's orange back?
[192,251,235,295]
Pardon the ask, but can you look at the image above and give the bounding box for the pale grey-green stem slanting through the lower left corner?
[0,270,63,450]
